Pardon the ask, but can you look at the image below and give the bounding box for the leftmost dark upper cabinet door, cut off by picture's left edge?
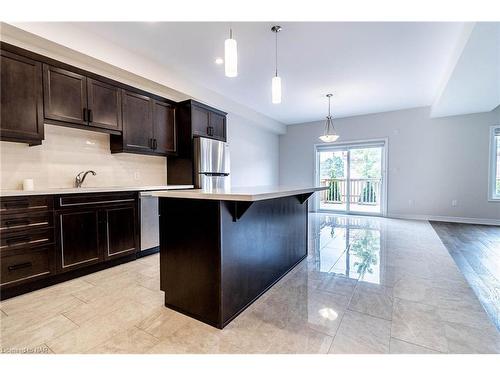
[0,51,43,144]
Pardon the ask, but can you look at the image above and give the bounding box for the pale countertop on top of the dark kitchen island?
[151,186,328,202]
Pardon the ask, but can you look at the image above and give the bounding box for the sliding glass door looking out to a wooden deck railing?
[316,141,386,215]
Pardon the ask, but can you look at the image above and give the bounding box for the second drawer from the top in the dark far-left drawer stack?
[0,211,54,235]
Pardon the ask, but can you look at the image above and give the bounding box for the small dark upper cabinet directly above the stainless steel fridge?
[177,100,227,157]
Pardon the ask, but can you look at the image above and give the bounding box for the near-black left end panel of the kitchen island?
[159,198,220,326]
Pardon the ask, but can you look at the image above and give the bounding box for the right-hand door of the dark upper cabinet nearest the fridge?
[153,100,177,155]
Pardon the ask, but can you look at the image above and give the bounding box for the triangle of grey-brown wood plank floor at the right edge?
[431,221,500,331]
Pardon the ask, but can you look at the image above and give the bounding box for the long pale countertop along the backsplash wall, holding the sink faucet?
[0,185,193,197]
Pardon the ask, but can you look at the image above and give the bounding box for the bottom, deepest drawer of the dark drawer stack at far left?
[1,246,54,286]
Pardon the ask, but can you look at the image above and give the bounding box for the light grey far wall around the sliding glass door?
[280,107,500,223]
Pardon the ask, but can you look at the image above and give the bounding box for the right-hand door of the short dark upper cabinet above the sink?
[87,78,122,131]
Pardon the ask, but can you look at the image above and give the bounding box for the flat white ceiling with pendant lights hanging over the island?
[64,22,464,124]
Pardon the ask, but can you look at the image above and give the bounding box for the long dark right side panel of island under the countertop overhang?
[221,196,308,325]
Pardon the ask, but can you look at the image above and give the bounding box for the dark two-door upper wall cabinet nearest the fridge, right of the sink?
[110,90,177,155]
